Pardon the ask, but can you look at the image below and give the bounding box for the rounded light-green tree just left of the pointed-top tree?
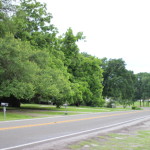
[32,50,71,107]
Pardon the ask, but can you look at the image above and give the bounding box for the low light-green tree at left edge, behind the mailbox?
[0,34,38,106]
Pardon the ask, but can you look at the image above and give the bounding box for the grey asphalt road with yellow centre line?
[0,110,150,150]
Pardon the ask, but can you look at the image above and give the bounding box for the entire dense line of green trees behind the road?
[0,0,150,107]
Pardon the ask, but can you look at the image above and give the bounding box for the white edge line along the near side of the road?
[0,116,150,150]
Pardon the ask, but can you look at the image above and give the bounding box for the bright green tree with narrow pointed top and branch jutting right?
[60,28,104,106]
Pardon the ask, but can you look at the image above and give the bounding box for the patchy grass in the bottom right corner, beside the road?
[69,130,150,150]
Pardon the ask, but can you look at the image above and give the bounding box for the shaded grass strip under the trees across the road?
[0,104,135,121]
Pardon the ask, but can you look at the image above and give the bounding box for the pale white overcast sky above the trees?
[38,0,150,73]
